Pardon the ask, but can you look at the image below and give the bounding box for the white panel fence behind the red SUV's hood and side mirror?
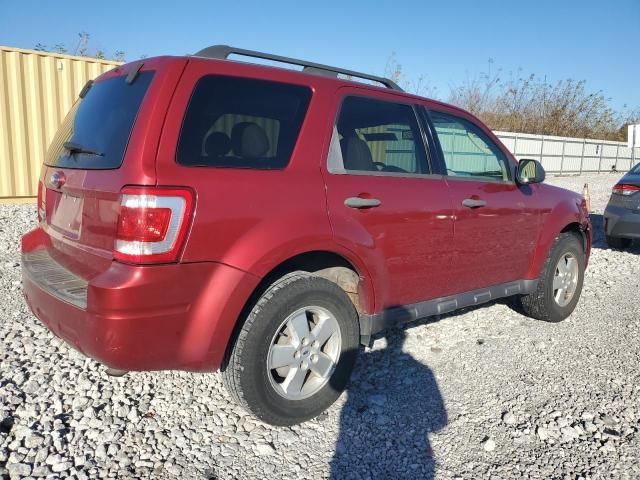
[494,132,640,173]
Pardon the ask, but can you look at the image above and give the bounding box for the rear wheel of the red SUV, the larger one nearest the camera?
[222,272,360,425]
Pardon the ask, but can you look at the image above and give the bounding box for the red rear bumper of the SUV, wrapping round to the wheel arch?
[22,235,258,371]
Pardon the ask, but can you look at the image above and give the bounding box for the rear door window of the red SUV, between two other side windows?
[329,97,428,173]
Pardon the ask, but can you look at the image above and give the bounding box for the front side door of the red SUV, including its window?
[430,110,539,292]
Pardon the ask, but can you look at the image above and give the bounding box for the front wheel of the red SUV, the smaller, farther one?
[520,233,585,322]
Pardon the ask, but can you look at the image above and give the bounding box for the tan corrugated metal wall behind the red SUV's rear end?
[0,46,120,198]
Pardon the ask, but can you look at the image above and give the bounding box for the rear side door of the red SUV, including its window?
[323,88,453,311]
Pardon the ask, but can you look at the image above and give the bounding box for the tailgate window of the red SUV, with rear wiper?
[45,72,153,170]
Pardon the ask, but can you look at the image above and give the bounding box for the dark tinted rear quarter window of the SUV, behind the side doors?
[176,75,311,169]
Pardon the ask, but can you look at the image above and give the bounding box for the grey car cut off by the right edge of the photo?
[604,163,640,248]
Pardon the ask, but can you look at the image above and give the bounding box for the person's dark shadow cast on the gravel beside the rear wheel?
[331,328,447,480]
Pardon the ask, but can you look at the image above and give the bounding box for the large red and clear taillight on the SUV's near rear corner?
[113,187,193,264]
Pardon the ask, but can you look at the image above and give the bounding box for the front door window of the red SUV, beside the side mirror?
[430,111,510,181]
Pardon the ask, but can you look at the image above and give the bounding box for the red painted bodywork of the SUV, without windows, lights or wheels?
[22,57,590,371]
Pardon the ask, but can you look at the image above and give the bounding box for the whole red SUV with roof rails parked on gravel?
[22,46,591,425]
